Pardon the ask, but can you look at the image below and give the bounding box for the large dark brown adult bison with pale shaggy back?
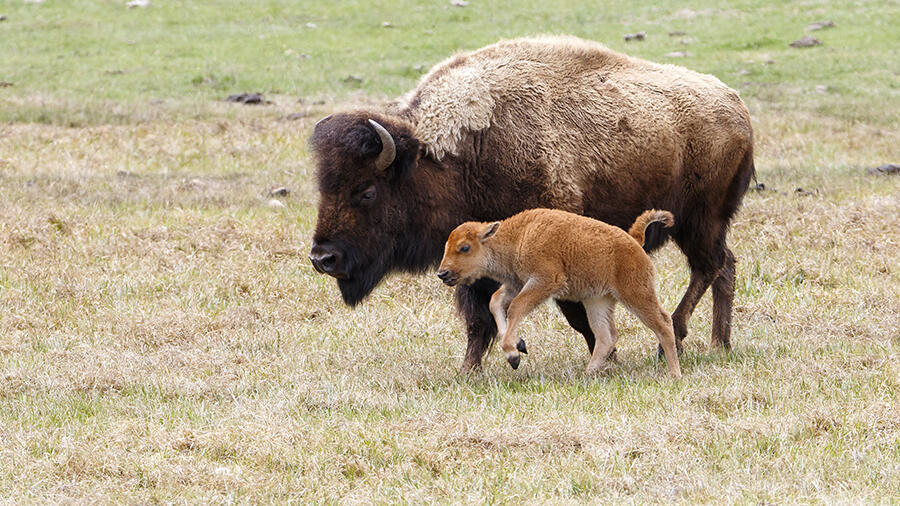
[309,37,754,370]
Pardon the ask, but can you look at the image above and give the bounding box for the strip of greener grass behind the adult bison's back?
[0,0,900,125]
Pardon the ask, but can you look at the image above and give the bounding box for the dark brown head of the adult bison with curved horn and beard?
[309,112,421,305]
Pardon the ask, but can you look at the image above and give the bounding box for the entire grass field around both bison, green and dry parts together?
[0,0,900,504]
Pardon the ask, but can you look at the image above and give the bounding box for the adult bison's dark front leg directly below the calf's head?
[456,278,500,372]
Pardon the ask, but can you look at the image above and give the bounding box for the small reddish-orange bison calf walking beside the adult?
[438,209,681,378]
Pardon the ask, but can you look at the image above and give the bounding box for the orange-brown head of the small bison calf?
[437,221,500,286]
